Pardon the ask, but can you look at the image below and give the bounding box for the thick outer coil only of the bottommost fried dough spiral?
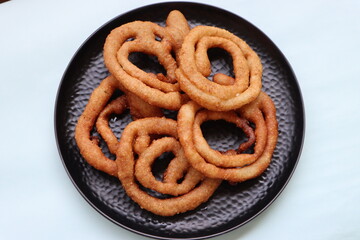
[116,118,221,216]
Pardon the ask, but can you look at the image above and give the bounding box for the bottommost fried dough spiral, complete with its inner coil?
[116,118,221,216]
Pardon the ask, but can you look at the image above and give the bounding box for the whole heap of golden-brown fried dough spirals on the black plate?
[75,10,278,216]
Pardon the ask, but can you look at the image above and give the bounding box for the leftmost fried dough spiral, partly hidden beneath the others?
[75,76,162,176]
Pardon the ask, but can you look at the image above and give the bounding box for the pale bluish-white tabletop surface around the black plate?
[0,0,360,240]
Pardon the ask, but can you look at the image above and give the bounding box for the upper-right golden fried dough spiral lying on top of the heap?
[176,26,262,111]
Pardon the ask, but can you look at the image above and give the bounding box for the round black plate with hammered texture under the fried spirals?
[55,2,304,239]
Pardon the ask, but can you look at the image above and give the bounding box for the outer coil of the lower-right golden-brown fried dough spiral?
[178,92,278,182]
